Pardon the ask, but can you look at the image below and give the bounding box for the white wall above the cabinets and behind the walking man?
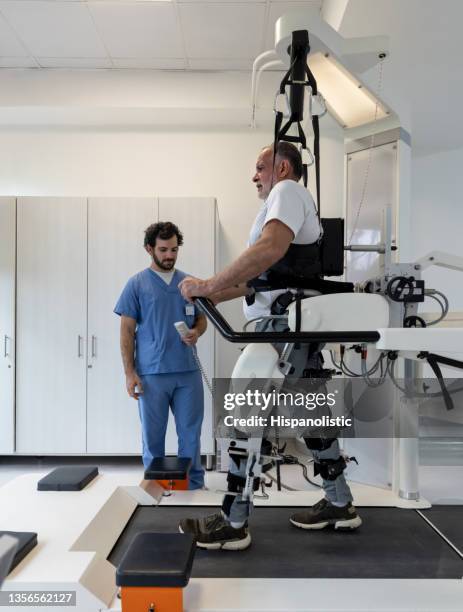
[0,123,342,376]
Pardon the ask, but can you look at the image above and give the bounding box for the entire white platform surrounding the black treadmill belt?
[0,470,463,612]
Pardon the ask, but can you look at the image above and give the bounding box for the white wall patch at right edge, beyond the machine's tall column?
[411,148,463,311]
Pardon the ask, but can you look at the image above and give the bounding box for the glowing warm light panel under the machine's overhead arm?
[308,53,389,128]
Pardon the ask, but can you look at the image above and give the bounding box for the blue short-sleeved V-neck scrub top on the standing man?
[114,268,198,376]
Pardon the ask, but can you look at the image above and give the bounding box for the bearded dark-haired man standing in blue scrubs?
[114,222,207,489]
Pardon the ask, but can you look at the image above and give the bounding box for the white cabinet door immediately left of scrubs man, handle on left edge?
[87,198,158,454]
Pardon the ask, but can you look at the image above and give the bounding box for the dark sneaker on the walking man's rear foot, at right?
[289,499,362,530]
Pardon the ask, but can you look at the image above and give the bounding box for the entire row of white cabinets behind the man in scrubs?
[11,197,216,455]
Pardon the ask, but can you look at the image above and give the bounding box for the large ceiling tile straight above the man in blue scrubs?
[89,2,184,58]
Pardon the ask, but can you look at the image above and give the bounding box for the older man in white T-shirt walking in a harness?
[180,141,362,550]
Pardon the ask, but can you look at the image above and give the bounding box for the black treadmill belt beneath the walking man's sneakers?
[108,506,463,579]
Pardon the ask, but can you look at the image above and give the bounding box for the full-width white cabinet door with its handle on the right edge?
[16,198,87,454]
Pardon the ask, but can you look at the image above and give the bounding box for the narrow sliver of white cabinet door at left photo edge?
[0,198,16,454]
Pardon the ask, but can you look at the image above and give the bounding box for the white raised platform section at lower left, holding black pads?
[0,473,160,612]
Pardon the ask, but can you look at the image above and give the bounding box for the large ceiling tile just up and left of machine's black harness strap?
[179,3,265,59]
